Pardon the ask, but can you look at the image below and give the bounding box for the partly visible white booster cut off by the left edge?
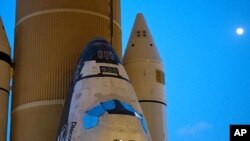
[0,17,11,141]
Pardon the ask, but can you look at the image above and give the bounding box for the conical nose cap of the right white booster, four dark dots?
[123,13,161,63]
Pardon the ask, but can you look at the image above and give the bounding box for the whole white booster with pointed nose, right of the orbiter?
[123,14,167,141]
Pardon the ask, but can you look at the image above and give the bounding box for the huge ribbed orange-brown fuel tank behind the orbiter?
[12,0,121,141]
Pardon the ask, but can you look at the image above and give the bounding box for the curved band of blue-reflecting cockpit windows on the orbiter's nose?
[82,99,148,133]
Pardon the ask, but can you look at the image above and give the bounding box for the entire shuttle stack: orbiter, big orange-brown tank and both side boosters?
[0,0,167,141]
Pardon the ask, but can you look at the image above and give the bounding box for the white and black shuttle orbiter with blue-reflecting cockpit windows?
[56,39,152,141]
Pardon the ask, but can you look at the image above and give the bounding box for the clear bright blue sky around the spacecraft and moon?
[0,0,250,141]
